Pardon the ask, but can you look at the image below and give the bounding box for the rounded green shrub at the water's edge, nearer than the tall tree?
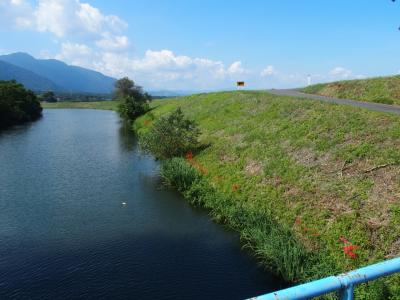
[139,108,200,159]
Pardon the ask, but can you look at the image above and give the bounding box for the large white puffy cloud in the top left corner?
[0,0,129,42]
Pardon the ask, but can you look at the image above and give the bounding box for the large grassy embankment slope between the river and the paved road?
[135,92,400,299]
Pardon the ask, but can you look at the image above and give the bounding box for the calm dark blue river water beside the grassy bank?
[0,110,280,299]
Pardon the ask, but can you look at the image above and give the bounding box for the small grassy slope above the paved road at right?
[302,76,400,105]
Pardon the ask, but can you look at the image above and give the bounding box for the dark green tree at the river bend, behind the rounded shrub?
[114,77,151,121]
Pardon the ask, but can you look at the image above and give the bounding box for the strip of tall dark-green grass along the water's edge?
[160,156,389,299]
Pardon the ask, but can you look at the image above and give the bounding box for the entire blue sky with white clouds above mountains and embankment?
[0,0,400,91]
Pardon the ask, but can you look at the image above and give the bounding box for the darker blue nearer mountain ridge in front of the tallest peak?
[0,61,64,91]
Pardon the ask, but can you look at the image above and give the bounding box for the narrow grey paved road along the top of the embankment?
[268,90,400,115]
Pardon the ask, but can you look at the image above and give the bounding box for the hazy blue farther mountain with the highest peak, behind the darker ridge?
[0,53,115,94]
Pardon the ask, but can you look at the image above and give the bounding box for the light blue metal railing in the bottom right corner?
[252,257,400,300]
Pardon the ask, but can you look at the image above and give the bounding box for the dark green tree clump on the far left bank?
[0,80,42,129]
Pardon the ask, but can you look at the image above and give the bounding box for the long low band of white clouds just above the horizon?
[65,48,248,89]
